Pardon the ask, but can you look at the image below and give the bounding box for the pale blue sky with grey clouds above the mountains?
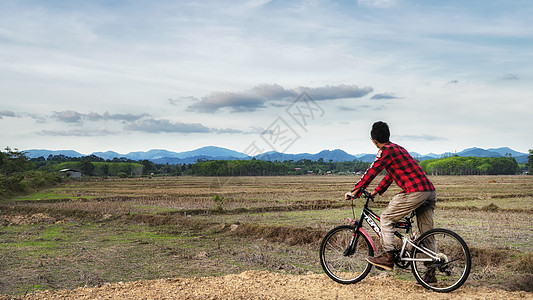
[0,0,533,156]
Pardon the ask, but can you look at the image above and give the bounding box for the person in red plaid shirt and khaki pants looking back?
[346,121,437,274]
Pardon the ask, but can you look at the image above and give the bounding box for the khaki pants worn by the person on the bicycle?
[381,191,437,251]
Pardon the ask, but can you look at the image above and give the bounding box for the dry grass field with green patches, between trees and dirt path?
[0,176,533,295]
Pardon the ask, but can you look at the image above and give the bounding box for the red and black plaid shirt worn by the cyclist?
[352,142,435,197]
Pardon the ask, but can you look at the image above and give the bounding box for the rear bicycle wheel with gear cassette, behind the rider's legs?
[411,228,472,293]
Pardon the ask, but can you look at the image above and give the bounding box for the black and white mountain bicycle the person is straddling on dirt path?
[319,190,472,292]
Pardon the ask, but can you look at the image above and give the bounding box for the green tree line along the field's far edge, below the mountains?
[0,147,533,197]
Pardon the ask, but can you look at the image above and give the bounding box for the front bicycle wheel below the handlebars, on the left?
[320,225,374,284]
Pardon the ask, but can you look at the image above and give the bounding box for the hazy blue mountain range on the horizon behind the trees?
[24,146,528,164]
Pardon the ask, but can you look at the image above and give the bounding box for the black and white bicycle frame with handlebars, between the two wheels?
[348,190,439,262]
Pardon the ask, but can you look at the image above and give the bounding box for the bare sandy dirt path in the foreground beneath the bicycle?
[5,271,533,300]
